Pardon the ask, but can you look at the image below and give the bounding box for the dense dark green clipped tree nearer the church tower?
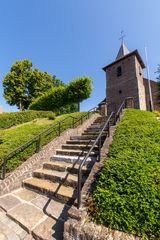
[30,77,92,112]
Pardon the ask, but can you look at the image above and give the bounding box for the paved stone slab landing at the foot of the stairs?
[0,188,69,240]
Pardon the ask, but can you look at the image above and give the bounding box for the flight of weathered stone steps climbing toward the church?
[23,117,107,204]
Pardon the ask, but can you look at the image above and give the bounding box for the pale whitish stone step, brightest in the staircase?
[50,154,97,165]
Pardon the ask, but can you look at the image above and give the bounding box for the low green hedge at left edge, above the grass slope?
[0,110,52,129]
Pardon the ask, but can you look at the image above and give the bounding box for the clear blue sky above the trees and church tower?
[0,0,160,111]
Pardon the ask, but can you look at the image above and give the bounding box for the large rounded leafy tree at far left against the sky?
[3,60,63,110]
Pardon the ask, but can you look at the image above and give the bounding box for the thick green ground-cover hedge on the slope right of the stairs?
[92,110,160,239]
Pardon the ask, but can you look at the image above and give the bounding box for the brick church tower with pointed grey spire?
[103,41,146,113]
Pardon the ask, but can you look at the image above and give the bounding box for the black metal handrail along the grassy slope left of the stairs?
[0,107,98,180]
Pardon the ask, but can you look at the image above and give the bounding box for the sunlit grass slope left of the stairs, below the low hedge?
[0,112,85,172]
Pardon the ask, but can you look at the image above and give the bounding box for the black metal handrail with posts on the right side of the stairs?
[77,97,134,209]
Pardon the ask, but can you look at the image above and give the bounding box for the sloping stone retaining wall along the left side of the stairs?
[0,113,99,195]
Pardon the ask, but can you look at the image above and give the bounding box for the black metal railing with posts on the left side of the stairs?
[0,107,97,179]
